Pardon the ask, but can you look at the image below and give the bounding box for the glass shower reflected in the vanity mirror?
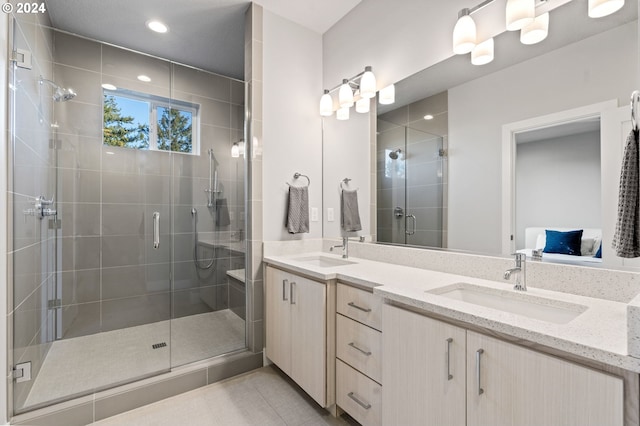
[376,118,447,247]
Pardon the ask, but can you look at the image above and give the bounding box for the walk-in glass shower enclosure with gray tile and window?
[8,17,246,413]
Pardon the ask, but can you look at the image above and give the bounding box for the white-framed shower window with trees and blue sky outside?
[103,89,200,154]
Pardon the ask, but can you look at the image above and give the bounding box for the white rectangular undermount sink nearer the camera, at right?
[426,283,587,324]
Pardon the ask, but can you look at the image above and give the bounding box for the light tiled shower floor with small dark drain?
[25,309,245,406]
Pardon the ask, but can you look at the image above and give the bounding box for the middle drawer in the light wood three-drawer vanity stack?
[336,315,382,383]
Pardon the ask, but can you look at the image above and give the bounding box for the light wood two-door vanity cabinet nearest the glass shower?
[264,266,333,407]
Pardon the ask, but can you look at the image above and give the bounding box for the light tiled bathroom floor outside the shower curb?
[94,366,357,426]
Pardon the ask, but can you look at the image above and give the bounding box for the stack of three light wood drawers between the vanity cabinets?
[336,282,383,426]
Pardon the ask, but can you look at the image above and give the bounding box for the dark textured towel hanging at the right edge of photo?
[612,130,640,258]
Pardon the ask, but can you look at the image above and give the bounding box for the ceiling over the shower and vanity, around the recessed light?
[46,0,361,79]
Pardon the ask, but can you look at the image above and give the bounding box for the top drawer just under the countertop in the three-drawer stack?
[336,283,382,330]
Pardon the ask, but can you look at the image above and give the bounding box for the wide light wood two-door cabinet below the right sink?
[382,305,624,426]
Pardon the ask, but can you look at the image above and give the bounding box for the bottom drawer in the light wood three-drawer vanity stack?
[336,359,382,426]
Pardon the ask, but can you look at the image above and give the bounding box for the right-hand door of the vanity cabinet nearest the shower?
[290,275,327,407]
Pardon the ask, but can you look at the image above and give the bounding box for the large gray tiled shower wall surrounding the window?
[45,32,244,337]
